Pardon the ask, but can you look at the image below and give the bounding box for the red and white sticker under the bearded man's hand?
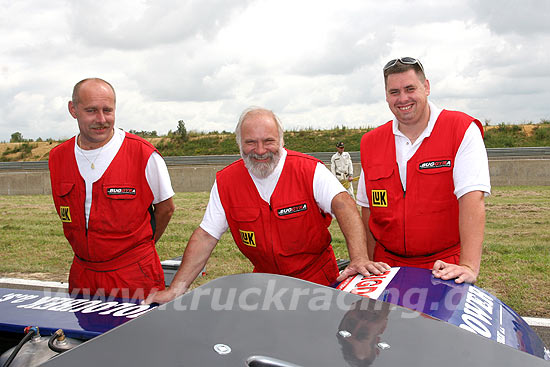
[336,267,400,299]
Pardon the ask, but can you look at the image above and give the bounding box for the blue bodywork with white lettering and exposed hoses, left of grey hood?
[0,288,152,367]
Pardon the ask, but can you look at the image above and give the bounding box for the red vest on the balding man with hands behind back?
[49,133,160,271]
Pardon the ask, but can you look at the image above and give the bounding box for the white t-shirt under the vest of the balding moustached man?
[74,128,174,227]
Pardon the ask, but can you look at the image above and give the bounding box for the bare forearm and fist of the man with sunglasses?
[433,191,485,283]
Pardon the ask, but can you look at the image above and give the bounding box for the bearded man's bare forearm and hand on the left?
[143,227,218,304]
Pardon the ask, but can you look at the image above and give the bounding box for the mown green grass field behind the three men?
[0,186,550,317]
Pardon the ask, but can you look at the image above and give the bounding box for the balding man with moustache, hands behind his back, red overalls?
[49,78,175,299]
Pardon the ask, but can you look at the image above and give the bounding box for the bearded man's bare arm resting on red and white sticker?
[332,192,390,281]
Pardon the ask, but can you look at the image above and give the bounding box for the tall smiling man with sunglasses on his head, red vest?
[357,57,491,283]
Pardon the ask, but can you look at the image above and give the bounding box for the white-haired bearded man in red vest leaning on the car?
[146,107,389,303]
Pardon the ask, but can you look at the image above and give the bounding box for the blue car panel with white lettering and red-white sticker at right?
[336,267,550,360]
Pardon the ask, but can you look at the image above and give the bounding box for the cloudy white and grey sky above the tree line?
[0,0,550,141]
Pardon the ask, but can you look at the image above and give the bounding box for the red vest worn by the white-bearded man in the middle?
[216,150,338,285]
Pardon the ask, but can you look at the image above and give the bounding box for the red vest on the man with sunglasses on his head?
[361,110,483,264]
